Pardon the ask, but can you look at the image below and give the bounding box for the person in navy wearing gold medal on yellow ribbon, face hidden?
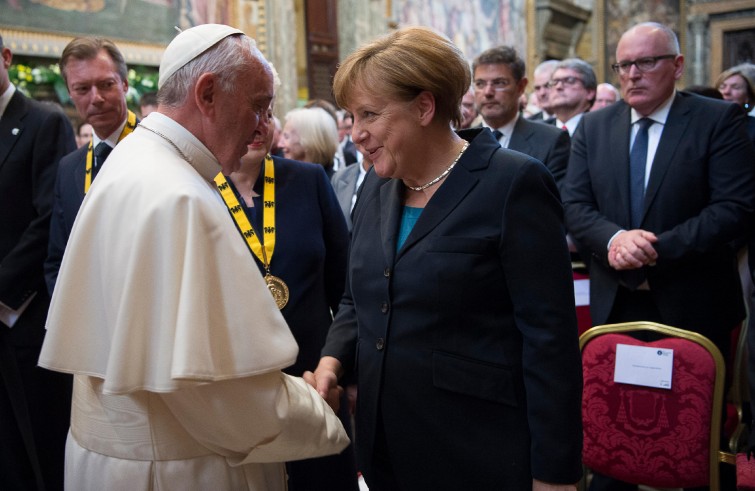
[215,109,358,491]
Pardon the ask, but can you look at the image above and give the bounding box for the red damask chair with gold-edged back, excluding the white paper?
[580,322,734,490]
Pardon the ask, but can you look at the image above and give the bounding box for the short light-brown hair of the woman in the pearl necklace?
[333,27,472,125]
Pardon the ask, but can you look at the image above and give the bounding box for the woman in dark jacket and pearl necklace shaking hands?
[305,27,582,491]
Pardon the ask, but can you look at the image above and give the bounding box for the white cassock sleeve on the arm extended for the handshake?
[160,372,349,466]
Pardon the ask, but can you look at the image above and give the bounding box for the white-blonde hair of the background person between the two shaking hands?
[286,107,338,169]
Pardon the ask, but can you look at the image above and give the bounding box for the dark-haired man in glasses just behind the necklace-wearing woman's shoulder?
[472,46,569,187]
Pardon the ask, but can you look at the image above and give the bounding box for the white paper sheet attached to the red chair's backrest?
[613,344,674,389]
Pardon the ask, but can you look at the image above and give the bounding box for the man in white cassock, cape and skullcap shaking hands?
[39,24,348,491]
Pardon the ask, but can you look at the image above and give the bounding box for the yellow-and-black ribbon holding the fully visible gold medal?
[215,154,275,274]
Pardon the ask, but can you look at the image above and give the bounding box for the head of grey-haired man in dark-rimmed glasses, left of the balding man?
[548,58,598,136]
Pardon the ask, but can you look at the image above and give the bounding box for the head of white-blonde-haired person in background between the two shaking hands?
[279,107,338,177]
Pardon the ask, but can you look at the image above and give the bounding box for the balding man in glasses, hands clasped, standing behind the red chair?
[563,23,755,489]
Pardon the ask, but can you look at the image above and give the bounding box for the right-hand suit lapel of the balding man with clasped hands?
[642,93,692,218]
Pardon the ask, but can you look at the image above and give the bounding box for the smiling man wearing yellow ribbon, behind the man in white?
[45,37,137,294]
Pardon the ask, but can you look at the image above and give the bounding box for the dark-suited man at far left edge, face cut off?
[0,31,76,491]
